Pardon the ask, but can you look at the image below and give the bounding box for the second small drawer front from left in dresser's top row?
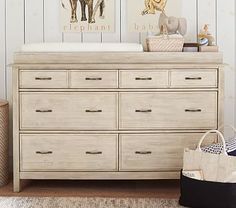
[70,71,118,88]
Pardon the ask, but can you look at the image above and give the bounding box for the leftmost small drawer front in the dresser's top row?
[20,70,68,88]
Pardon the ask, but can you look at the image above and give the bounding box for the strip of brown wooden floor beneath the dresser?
[0,180,179,199]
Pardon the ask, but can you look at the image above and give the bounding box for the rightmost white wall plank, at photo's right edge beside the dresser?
[217,0,236,132]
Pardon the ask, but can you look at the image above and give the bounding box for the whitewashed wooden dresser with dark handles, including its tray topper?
[13,52,224,192]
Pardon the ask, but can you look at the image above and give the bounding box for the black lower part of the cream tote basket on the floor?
[179,171,236,208]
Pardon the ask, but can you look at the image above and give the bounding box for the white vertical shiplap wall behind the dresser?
[0,0,236,128]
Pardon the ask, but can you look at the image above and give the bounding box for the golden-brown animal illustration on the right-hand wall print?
[142,0,167,15]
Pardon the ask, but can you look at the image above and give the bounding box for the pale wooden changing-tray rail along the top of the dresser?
[14,52,223,65]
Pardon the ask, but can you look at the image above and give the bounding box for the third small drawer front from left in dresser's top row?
[120,70,168,88]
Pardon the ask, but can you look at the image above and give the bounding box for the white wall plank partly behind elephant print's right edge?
[102,0,121,42]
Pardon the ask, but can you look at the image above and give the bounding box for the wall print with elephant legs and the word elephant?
[60,0,116,32]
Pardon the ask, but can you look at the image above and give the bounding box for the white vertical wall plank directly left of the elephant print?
[43,0,62,42]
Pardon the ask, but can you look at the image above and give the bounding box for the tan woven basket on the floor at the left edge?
[0,100,9,186]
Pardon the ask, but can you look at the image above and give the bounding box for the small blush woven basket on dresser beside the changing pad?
[146,35,184,52]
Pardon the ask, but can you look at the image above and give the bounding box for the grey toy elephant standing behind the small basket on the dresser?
[159,13,187,36]
